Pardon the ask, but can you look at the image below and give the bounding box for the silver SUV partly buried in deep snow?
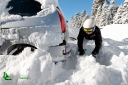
[0,0,70,61]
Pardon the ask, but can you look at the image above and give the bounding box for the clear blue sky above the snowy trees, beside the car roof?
[58,0,124,21]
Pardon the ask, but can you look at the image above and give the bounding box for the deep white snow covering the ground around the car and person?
[0,24,128,85]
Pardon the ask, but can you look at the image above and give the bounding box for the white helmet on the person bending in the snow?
[83,18,95,29]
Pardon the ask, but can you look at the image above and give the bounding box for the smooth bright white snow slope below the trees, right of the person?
[101,24,128,41]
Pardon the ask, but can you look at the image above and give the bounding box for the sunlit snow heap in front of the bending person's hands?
[61,56,128,85]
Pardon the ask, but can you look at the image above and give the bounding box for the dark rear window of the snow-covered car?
[6,0,41,16]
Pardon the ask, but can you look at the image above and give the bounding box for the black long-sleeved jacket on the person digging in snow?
[77,26,102,54]
